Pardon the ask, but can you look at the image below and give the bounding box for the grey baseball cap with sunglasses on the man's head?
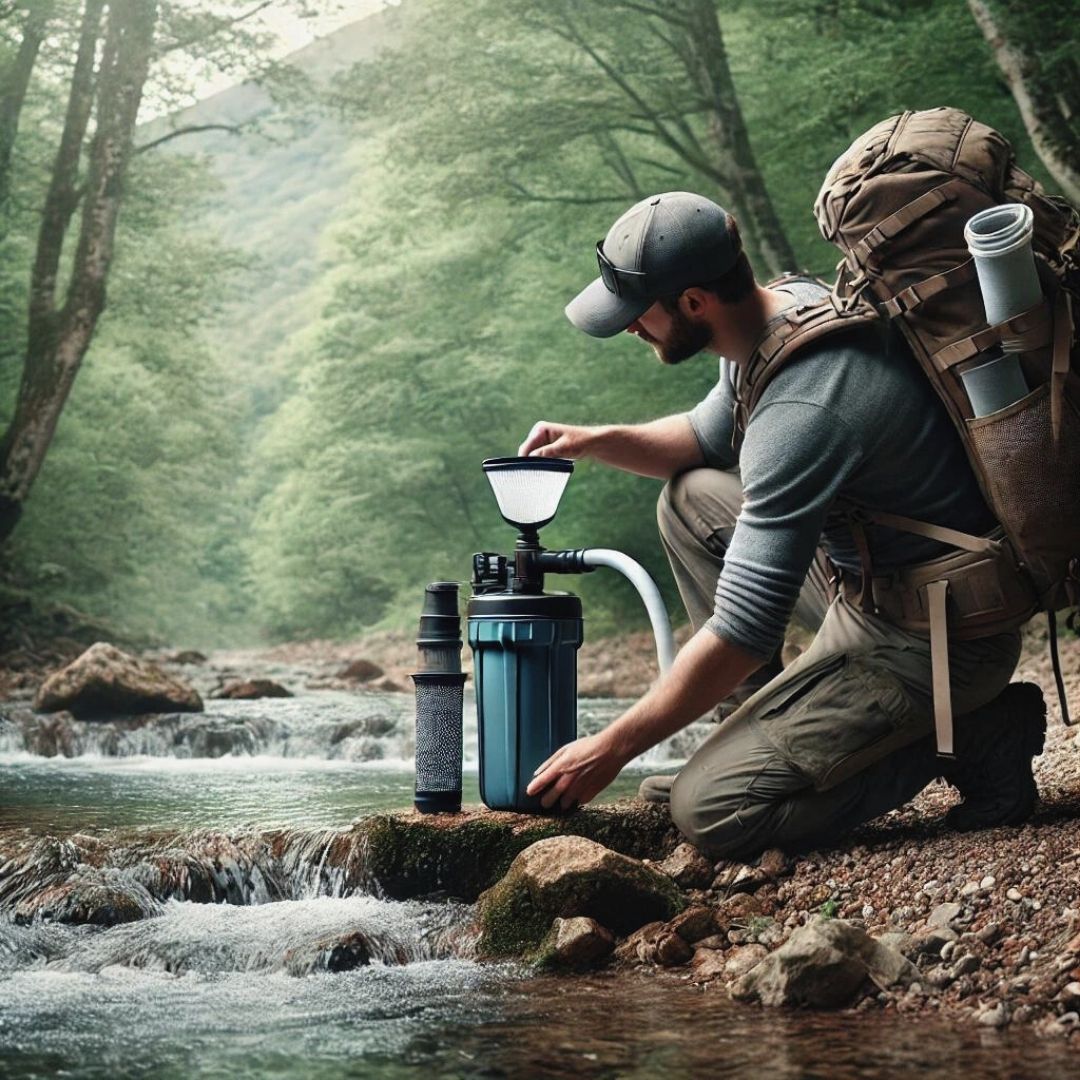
[566,191,741,337]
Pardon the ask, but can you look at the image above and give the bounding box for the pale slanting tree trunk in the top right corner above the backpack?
[968,0,1080,203]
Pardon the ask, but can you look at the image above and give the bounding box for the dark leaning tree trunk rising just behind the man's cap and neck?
[677,0,796,278]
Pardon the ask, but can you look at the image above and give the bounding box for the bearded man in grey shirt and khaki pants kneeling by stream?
[521,191,1045,859]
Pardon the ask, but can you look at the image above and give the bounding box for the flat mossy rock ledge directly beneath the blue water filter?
[352,801,678,902]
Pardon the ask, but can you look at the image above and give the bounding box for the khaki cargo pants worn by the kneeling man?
[646,469,1020,860]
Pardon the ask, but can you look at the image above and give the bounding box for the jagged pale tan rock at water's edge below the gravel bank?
[731,919,918,1009]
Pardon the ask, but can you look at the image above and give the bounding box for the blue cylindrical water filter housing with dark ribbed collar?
[469,591,582,813]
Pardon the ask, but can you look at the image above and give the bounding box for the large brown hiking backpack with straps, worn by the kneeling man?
[740,108,1080,748]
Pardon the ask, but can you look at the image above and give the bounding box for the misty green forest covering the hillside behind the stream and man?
[0,0,1080,646]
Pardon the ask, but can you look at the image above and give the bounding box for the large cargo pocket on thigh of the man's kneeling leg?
[754,656,931,791]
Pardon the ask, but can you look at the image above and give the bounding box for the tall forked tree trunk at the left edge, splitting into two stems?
[0,0,157,542]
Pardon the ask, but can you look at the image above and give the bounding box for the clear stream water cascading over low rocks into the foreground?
[0,691,1076,1078]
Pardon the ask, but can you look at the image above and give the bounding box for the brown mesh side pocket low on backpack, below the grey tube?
[968,384,1080,603]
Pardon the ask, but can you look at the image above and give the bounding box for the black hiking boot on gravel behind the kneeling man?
[944,683,1047,832]
